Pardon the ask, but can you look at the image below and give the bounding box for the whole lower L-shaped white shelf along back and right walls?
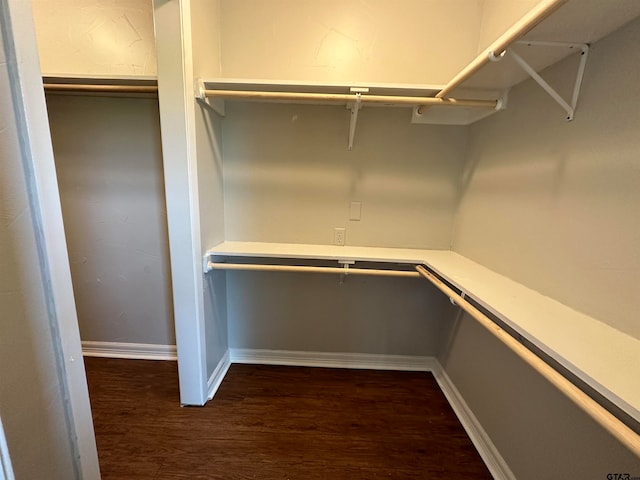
[207,242,640,422]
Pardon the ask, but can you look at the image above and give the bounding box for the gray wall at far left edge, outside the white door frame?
[0,21,75,479]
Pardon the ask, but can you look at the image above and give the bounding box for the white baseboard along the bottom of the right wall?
[432,359,516,480]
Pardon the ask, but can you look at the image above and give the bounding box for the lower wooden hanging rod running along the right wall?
[416,265,640,458]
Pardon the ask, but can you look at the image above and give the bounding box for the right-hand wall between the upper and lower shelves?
[453,15,640,338]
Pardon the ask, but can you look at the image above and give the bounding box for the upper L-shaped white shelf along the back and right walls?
[199,0,640,126]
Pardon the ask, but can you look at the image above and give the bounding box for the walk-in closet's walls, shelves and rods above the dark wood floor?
[2,0,640,479]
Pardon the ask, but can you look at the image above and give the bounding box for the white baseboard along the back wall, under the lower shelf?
[230,348,435,372]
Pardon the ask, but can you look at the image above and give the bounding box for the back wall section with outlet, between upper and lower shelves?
[223,102,467,249]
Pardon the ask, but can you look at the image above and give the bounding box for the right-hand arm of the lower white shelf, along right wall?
[425,252,640,422]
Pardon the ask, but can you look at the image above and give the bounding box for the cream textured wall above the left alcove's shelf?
[32,0,156,76]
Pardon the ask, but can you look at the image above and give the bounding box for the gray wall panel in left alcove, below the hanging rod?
[47,95,175,345]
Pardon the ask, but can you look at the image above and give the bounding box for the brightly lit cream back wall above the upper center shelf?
[221,0,482,84]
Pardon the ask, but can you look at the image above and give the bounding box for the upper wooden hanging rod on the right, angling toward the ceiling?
[418,0,568,114]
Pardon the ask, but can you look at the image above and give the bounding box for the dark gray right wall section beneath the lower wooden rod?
[440,315,640,480]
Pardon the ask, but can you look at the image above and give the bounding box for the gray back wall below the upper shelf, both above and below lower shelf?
[222,102,466,355]
